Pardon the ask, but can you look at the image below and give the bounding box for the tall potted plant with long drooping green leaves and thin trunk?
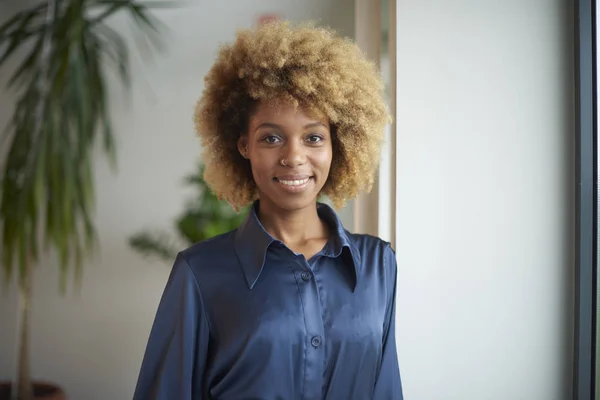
[0,0,159,400]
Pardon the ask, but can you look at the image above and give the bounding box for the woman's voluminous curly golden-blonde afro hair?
[194,21,389,209]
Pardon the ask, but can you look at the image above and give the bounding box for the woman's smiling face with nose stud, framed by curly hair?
[238,102,332,211]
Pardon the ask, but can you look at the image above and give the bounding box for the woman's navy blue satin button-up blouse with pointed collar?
[134,203,403,400]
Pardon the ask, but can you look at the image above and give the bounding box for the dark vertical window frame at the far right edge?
[573,0,598,400]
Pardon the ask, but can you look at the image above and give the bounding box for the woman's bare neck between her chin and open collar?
[258,198,328,246]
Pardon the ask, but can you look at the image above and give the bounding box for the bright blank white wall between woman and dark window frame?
[396,0,576,400]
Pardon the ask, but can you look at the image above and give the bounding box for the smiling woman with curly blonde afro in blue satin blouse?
[134,22,402,400]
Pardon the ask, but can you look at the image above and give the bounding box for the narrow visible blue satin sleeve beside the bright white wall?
[373,248,403,400]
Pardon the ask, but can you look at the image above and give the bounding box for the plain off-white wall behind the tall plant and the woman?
[0,0,354,400]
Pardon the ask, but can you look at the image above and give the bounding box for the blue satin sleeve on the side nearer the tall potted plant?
[133,254,209,400]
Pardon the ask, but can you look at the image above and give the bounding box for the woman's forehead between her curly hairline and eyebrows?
[250,100,329,126]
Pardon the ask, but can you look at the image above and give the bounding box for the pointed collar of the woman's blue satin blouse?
[234,200,361,290]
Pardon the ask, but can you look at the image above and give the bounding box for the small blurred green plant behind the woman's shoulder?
[129,164,247,262]
